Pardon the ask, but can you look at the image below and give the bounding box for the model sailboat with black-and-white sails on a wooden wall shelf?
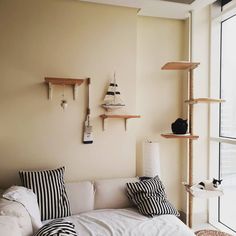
[102,73,125,110]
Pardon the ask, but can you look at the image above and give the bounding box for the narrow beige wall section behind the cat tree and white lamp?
[136,17,185,209]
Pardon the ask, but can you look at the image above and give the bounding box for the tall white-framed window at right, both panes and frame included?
[209,1,236,234]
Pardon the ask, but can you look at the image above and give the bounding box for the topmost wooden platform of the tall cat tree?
[161,61,200,70]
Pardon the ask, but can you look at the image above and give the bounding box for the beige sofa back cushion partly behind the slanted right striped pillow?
[94,178,138,209]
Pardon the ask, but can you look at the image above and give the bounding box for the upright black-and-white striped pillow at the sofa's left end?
[19,167,71,220]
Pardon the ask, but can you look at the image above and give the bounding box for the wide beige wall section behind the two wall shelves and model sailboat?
[0,0,138,186]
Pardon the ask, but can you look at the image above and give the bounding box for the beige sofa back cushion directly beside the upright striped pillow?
[65,181,94,215]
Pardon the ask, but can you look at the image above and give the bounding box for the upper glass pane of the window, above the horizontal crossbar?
[220,16,236,138]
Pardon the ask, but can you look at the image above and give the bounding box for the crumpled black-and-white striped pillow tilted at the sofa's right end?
[126,176,179,217]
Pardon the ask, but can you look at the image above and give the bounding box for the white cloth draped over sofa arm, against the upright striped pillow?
[2,186,43,231]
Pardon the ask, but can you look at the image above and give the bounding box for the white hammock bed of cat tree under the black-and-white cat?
[183,183,224,198]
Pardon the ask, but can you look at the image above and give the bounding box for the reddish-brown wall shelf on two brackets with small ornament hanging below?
[45,77,84,100]
